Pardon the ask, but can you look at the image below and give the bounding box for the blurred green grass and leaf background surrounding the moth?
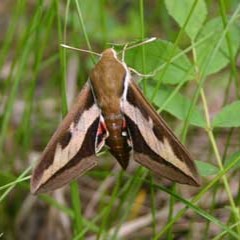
[0,0,240,239]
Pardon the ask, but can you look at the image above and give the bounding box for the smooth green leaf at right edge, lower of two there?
[212,101,240,127]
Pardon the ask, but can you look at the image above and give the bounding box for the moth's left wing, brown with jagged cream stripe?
[31,82,100,193]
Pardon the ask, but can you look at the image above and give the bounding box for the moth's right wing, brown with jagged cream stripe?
[122,80,199,186]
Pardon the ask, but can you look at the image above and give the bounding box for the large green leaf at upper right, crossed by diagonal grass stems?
[196,18,240,75]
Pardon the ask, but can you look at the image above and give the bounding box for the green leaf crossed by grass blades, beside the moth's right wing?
[147,86,205,128]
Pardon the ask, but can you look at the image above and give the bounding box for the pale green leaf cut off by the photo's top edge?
[165,0,207,39]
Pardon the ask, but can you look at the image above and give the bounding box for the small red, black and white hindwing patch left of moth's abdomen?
[95,115,109,153]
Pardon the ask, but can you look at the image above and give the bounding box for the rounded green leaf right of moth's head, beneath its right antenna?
[125,40,193,84]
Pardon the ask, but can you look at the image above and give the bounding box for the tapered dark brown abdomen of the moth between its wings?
[104,114,131,169]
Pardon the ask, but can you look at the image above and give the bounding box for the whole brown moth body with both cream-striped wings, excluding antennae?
[31,48,199,194]
